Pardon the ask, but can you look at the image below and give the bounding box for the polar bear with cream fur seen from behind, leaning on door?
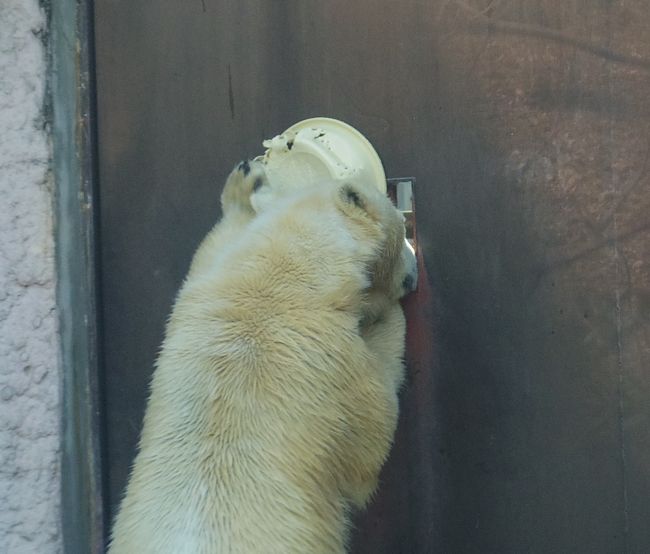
[109,162,413,554]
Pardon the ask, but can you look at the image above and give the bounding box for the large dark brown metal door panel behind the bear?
[96,0,650,554]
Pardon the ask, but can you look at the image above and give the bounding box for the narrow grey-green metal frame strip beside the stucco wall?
[52,0,105,554]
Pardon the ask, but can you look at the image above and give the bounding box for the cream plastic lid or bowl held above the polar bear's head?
[260,117,386,193]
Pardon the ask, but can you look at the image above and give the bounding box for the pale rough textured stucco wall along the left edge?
[0,0,61,554]
